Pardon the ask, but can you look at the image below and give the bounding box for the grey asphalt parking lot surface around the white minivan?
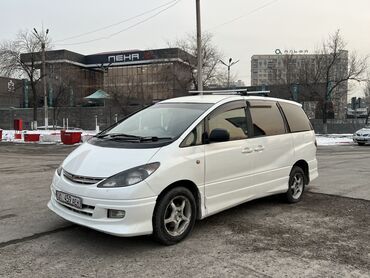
[0,143,370,277]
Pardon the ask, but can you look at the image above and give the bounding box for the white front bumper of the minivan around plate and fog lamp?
[48,184,156,236]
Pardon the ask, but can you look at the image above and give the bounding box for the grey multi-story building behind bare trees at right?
[251,51,348,119]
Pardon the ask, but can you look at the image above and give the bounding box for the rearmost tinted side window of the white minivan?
[279,102,312,132]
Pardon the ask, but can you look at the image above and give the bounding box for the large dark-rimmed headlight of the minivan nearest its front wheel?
[98,162,160,188]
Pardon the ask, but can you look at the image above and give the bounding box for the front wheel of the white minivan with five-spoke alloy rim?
[153,187,197,245]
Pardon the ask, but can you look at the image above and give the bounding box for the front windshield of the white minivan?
[99,103,212,139]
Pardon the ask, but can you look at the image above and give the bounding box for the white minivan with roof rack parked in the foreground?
[48,95,318,245]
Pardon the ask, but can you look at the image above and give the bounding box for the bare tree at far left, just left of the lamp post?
[0,30,50,125]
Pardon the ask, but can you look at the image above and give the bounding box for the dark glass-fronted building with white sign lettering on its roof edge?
[22,48,195,106]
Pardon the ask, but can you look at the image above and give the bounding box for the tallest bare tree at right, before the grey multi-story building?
[277,30,367,132]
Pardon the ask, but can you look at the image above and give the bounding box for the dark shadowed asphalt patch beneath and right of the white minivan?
[52,192,370,272]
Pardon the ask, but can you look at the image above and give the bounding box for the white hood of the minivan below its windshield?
[62,143,160,178]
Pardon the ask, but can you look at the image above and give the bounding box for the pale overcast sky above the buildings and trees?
[0,0,370,95]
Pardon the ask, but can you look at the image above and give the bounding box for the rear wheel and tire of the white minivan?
[285,166,306,204]
